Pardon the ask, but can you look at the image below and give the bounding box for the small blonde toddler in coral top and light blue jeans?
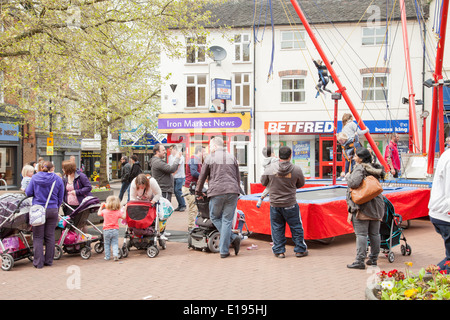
[98,196,126,261]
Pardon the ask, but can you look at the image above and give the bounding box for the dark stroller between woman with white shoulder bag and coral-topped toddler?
[53,196,104,260]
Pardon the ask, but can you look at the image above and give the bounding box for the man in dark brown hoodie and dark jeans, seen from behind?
[261,147,308,258]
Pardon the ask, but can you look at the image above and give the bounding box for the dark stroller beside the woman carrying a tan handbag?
[370,196,411,263]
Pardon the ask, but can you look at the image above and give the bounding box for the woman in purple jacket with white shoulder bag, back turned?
[25,161,64,269]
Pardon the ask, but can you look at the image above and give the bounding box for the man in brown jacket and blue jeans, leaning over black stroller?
[195,137,241,258]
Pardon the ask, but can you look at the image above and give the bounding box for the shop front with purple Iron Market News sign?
[158,112,252,191]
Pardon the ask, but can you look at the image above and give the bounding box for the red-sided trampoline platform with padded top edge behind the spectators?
[237,185,431,240]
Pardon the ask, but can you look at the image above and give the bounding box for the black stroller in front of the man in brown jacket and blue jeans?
[188,183,251,253]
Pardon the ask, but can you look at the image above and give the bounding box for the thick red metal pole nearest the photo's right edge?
[427,0,449,175]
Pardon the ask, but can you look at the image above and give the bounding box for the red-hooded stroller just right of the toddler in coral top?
[121,201,166,258]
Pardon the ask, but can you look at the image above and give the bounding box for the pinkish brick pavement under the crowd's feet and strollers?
[0,181,444,300]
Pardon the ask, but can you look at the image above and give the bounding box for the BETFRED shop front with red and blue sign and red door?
[264,120,409,179]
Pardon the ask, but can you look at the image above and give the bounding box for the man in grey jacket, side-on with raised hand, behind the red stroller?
[151,143,181,201]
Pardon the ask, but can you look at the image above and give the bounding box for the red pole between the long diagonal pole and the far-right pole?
[400,0,419,153]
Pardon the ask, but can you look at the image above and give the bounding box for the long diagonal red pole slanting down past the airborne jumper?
[291,0,389,172]
